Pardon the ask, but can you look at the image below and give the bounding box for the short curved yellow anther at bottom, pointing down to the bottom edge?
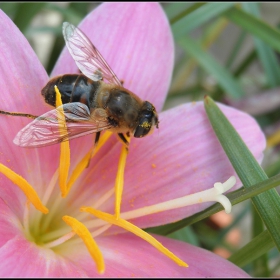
[62,216,105,274]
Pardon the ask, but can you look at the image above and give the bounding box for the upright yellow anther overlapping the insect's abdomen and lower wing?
[54,86,70,197]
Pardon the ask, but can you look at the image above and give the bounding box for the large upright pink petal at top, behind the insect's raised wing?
[52,2,174,111]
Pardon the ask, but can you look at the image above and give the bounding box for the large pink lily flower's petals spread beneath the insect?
[0,3,265,277]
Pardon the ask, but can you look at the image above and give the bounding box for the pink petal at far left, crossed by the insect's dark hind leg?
[0,11,58,206]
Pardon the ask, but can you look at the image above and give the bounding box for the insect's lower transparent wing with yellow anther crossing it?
[14,102,112,148]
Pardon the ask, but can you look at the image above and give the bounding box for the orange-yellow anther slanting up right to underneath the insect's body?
[67,131,112,192]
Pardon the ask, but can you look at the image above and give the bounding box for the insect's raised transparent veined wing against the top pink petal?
[62,22,121,86]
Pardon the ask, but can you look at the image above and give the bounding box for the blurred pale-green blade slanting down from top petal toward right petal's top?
[178,37,245,98]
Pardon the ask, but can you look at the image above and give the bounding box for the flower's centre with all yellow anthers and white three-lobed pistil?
[0,87,235,273]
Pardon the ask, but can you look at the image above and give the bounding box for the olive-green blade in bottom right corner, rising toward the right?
[228,230,274,267]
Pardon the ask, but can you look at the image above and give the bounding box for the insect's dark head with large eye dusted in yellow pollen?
[134,101,159,138]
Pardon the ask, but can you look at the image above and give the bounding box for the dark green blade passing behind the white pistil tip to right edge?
[145,174,280,235]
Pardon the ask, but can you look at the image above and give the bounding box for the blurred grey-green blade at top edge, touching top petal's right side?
[171,2,235,40]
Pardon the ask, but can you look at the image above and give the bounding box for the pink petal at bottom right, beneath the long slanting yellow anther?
[62,234,248,278]
